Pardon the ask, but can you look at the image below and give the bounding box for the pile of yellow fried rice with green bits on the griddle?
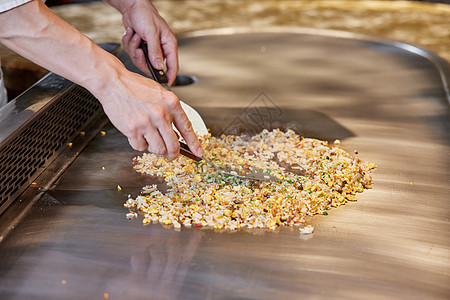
[125,129,376,230]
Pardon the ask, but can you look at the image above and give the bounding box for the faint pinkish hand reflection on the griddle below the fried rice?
[105,230,203,299]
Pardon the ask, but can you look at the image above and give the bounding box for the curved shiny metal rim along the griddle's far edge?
[177,26,450,105]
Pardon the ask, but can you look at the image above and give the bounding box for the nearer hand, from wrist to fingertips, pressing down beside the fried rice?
[99,71,203,160]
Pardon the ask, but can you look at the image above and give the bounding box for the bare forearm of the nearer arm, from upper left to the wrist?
[0,1,123,101]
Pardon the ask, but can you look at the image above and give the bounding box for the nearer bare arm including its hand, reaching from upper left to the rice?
[0,0,202,159]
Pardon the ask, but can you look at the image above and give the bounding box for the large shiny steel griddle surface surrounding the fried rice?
[0,28,450,299]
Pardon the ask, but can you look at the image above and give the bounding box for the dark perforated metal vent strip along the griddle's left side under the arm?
[0,85,102,213]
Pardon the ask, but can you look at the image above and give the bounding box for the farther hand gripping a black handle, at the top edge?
[105,0,178,85]
